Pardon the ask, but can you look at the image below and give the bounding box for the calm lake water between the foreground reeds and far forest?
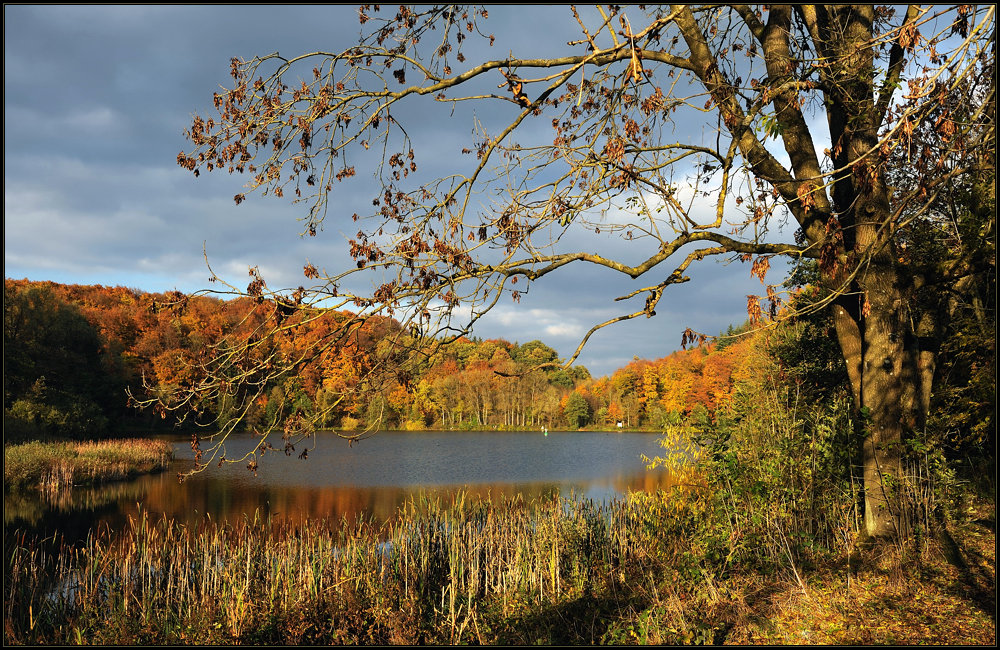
[4,431,670,540]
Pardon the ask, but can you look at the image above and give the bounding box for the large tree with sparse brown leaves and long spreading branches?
[172,5,995,535]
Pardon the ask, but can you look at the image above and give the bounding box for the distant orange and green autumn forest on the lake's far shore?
[4,279,754,437]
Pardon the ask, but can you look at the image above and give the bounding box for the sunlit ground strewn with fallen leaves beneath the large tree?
[713,504,997,646]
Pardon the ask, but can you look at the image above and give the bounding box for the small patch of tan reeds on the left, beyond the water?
[3,438,173,490]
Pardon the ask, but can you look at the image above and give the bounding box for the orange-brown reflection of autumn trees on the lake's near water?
[4,434,672,540]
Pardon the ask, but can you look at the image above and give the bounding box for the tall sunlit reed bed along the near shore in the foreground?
[4,495,669,644]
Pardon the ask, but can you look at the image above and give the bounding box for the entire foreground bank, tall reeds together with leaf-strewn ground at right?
[4,494,996,645]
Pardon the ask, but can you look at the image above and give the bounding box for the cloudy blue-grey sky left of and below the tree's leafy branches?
[4,5,796,376]
